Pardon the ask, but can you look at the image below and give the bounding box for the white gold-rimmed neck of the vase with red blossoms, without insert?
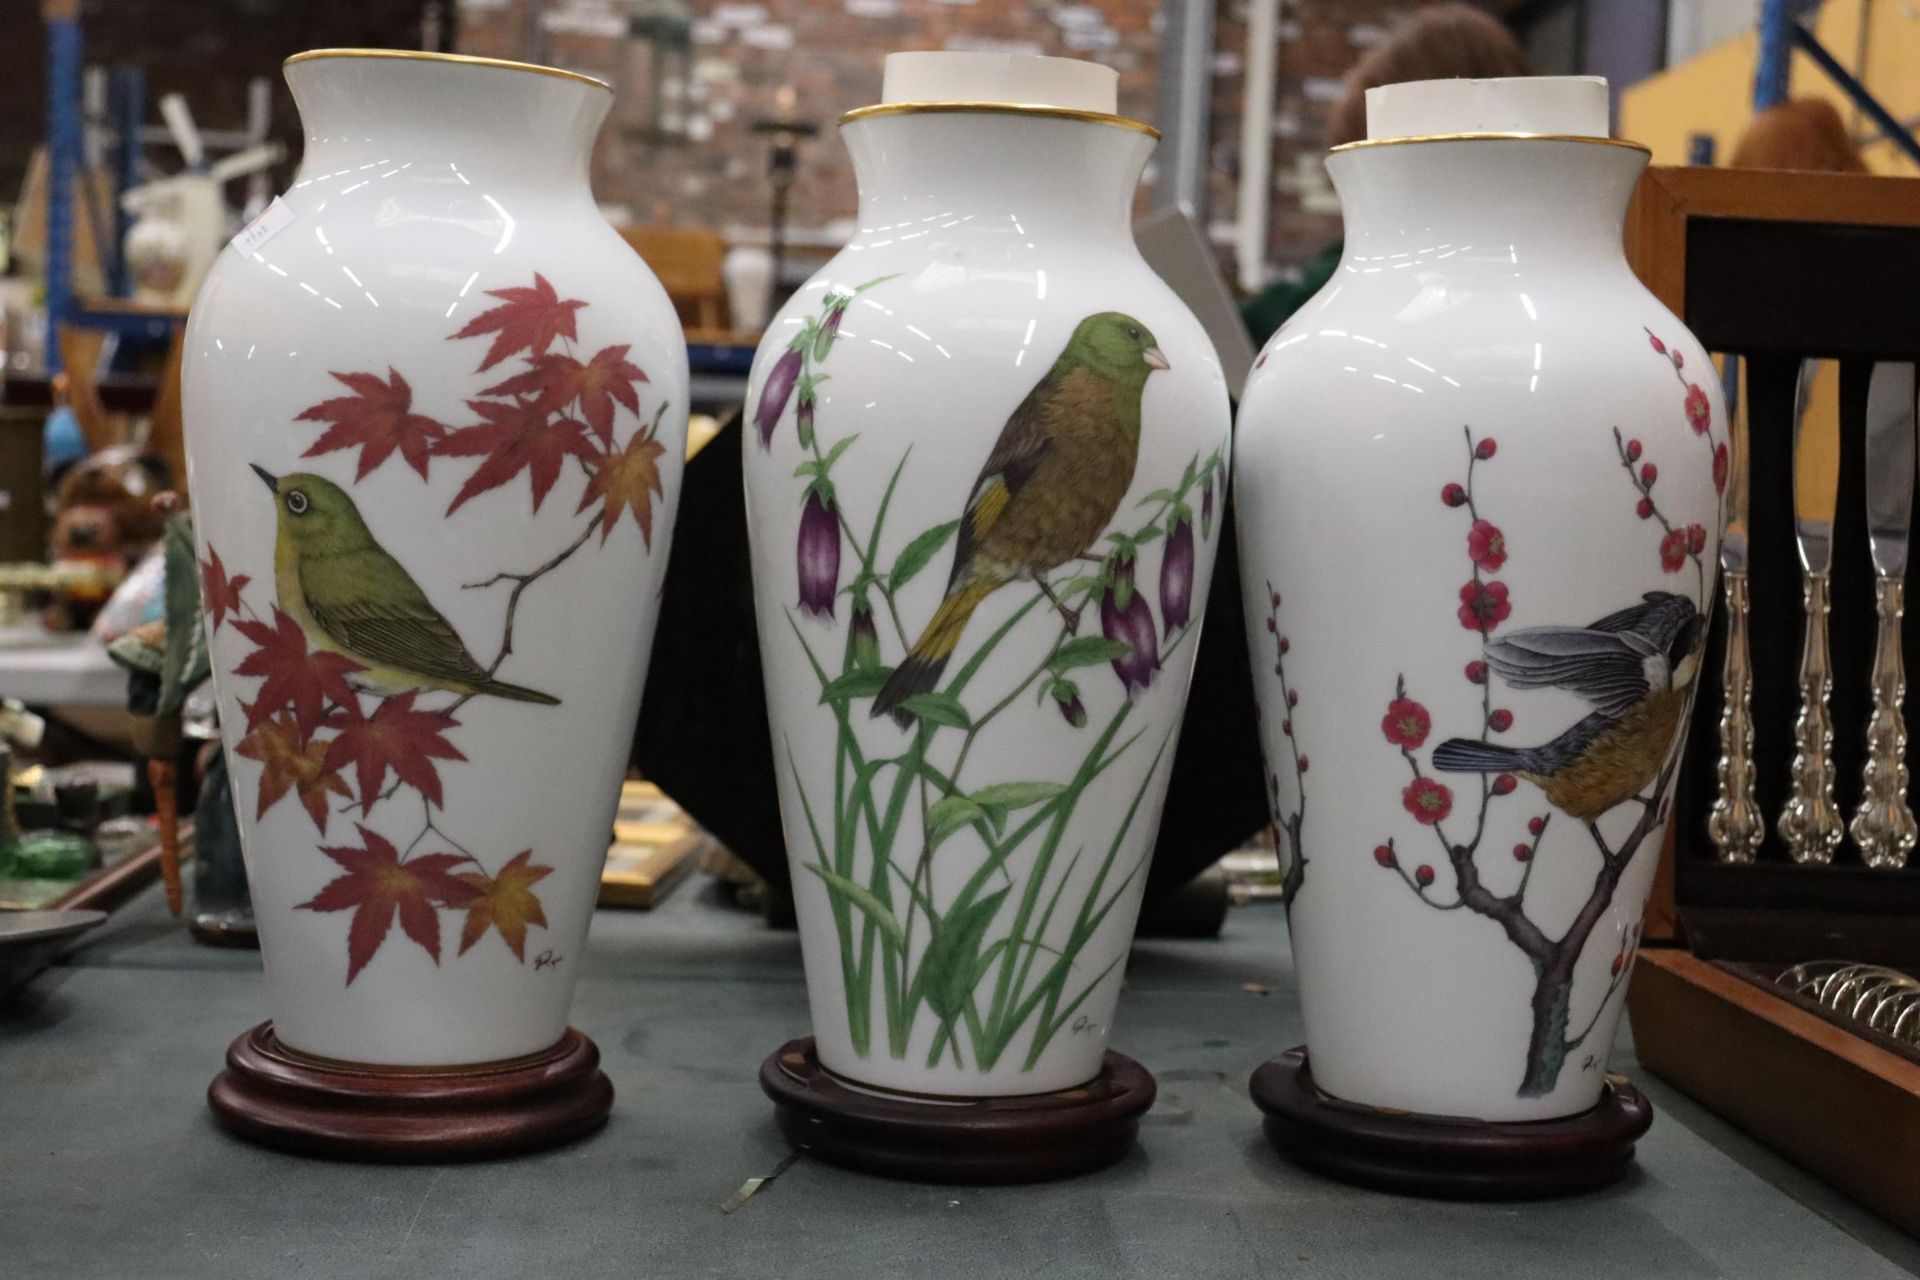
[1327,138,1647,278]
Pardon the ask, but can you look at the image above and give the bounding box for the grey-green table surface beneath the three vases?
[0,877,1920,1280]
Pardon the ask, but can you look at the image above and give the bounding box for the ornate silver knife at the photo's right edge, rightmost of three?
[1847,361,1920,867]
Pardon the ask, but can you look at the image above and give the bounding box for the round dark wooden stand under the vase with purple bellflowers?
[760,1036,1154,1184]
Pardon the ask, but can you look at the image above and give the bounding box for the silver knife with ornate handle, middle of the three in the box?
[1780,361,1847,864]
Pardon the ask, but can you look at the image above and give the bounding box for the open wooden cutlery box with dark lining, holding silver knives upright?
[1626,167,1920,1230]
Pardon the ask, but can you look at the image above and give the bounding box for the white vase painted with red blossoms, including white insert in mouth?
[1235,79,1728,1121]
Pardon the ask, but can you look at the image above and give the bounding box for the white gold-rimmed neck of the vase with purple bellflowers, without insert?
[843,111,1154,248]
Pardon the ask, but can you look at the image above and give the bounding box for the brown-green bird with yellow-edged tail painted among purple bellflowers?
[874,311,1167,725]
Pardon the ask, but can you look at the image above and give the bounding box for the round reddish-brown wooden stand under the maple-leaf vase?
[207,1023,612,1163]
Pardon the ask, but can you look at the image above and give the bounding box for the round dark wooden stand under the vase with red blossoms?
[1248,1048,1653,1199]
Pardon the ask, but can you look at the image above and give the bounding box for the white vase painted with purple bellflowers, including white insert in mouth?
[747,54,1229,1096]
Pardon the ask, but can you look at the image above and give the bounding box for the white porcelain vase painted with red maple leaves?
[184,50,687,1067]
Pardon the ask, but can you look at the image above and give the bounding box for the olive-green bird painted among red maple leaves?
[253,466,559,706]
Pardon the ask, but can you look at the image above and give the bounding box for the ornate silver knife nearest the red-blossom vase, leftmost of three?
[1707,355,1766,864]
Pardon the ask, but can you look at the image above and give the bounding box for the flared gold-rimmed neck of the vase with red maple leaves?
[286,54,612,192]
